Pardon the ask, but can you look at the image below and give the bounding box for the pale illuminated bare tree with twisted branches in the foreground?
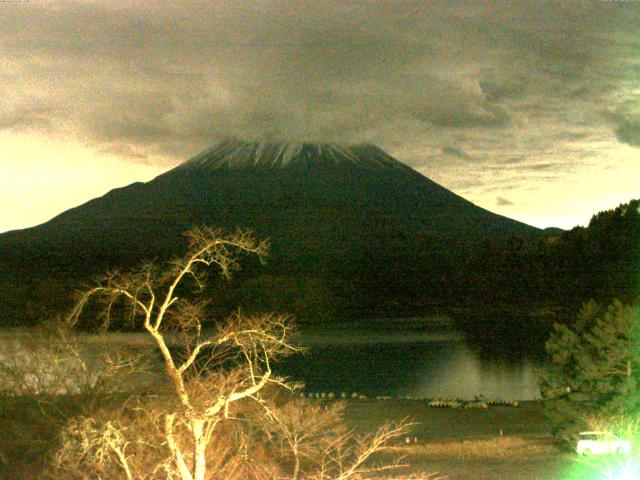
[69,228,302,480]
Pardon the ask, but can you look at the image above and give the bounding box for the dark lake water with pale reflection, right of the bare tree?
[278,327,540,400]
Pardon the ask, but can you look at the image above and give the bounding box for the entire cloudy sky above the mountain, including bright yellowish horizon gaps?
[0,0,640,232]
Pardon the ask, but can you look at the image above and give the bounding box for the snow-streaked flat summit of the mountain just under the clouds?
[171,139,407,170]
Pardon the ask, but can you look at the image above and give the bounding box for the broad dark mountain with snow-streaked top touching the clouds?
[0,141,537,268]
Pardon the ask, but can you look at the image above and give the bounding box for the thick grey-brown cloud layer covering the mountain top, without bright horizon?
[0,0,640,168]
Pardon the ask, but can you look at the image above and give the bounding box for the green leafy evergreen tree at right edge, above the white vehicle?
[540,300,640,439]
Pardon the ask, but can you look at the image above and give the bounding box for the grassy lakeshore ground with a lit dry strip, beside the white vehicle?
[345,400,576,480]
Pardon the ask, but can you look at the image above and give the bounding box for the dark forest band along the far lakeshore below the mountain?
[0,200,640,345]
